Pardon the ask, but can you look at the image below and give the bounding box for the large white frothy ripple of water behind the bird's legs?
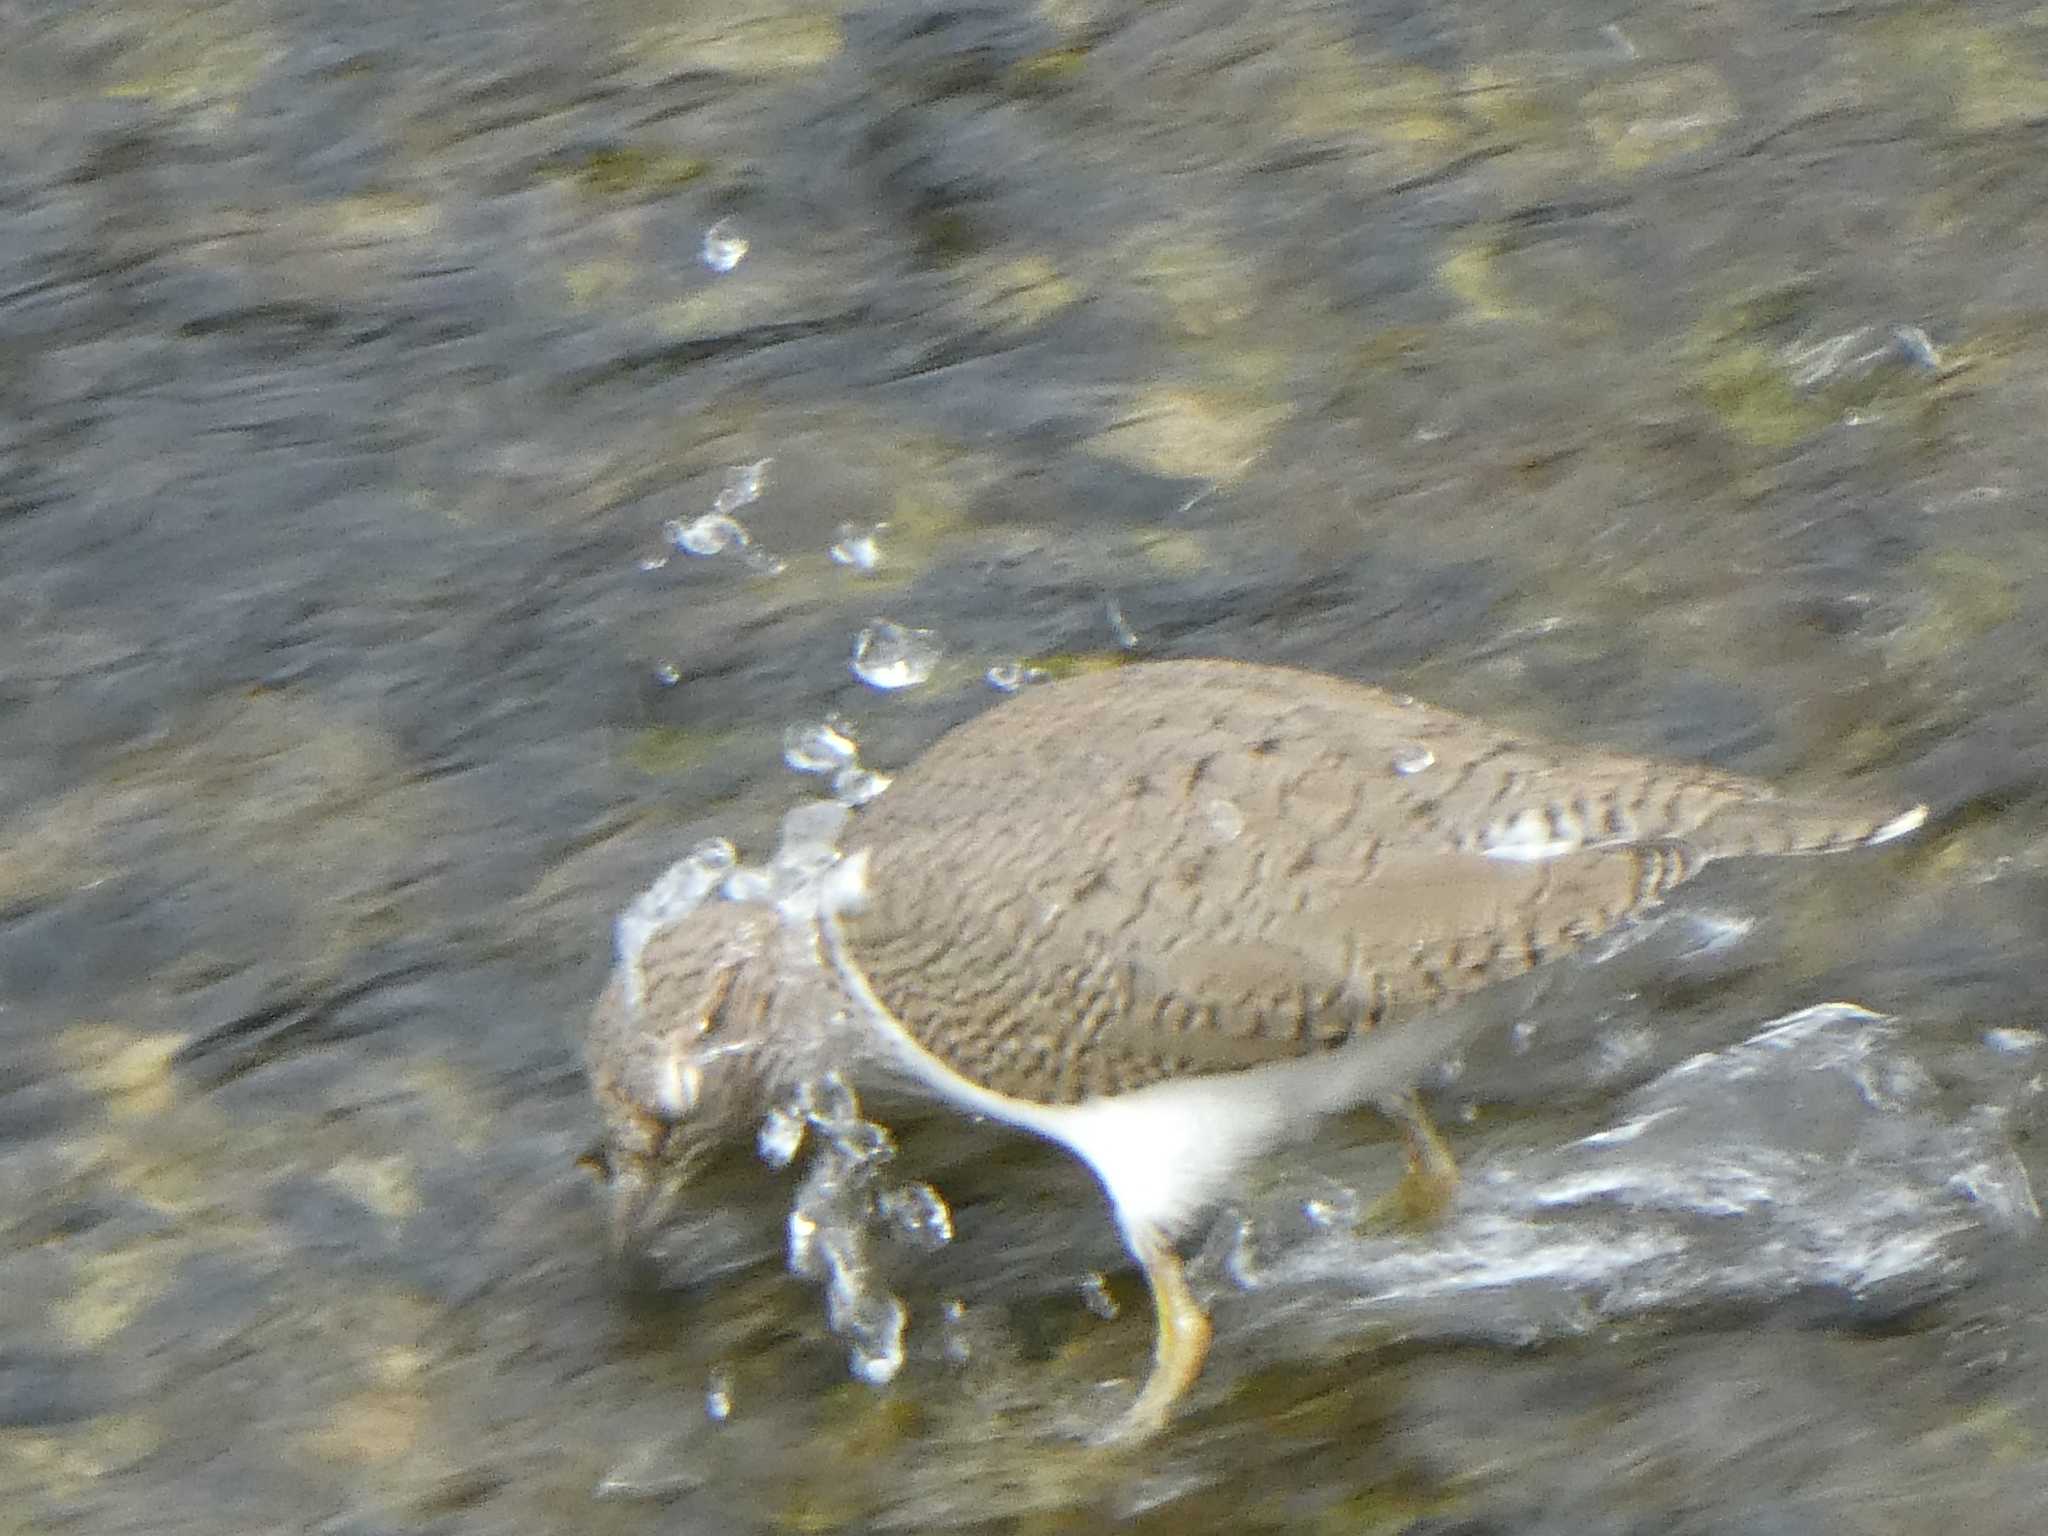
[1221,1004,2040,1341]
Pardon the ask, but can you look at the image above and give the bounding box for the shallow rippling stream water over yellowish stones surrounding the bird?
[0,0,2048,1536]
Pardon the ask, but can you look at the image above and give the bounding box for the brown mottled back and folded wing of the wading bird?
[846,662,1916,1102]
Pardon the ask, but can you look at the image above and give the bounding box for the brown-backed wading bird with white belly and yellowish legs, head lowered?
[590,662,1925,1434]
